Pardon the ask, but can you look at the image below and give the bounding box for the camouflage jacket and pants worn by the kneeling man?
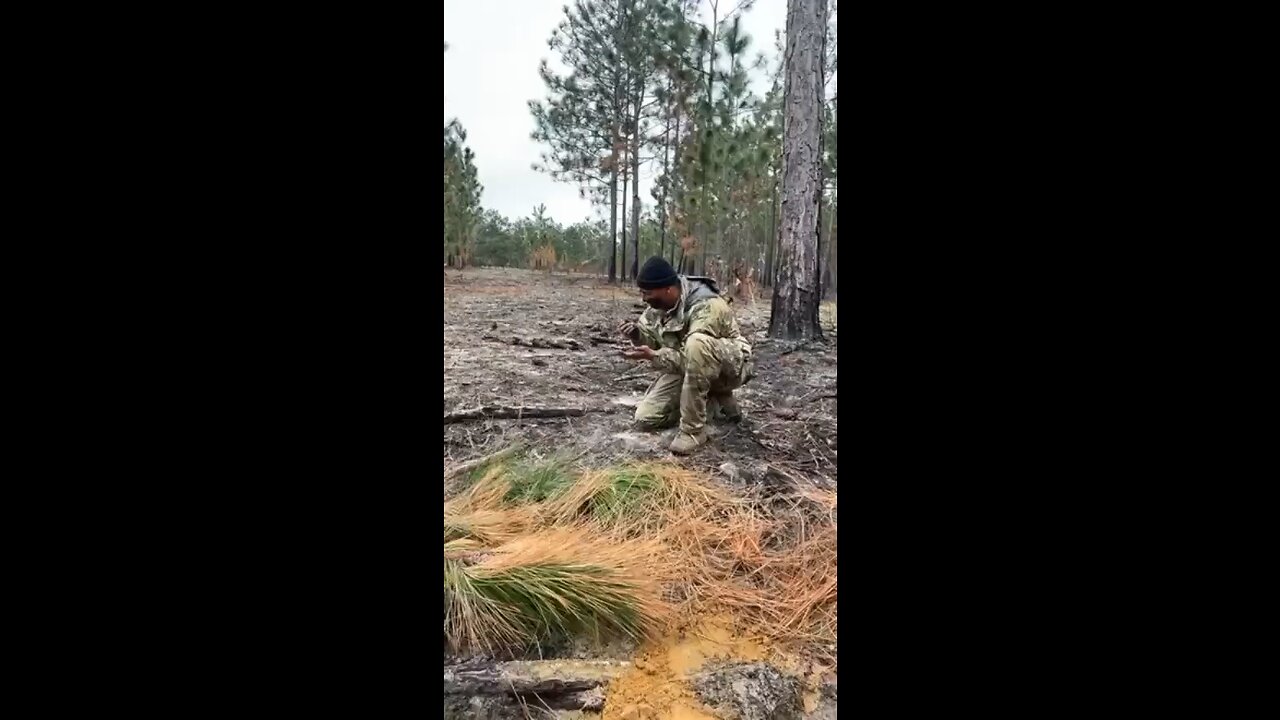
[635,275,755,436]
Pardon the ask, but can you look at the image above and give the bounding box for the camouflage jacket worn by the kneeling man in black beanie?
[636,275,751,374]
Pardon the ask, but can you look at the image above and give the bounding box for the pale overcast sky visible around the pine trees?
[444,0,833,224]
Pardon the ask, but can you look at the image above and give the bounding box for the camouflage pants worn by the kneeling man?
[635,333,754,434]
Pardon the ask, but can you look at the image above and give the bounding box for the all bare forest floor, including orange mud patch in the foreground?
[444,268,837,720]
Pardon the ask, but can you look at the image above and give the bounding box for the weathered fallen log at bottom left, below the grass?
[444,660,631,711]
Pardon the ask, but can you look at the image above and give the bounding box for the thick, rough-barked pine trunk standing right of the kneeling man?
[769,0,827,340]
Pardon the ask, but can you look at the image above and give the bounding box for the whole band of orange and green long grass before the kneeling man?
[445,456,837,660]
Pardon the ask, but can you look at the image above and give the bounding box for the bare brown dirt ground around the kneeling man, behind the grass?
[444,268,837,486]
